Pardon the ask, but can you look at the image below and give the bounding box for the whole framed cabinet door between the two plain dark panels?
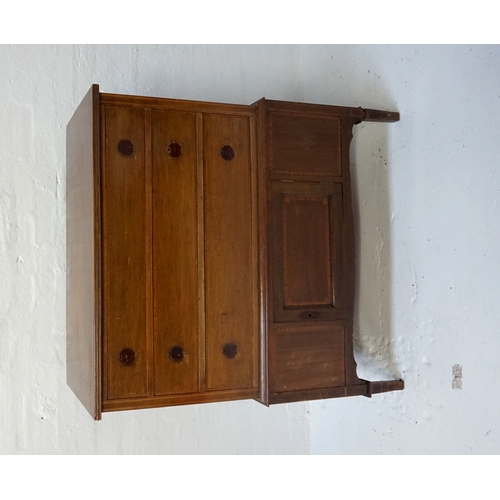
[270,181,345,322]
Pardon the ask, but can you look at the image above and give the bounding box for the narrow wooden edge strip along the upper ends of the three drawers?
[99,93,255,116]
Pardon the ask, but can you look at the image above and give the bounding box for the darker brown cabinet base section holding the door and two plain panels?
[258,101,366,404]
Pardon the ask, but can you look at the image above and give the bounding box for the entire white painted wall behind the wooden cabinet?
[0,45,500,454]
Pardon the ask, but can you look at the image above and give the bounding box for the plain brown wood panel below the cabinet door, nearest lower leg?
[270,323,345,393]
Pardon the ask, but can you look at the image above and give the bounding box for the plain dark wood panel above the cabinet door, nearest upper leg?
[269,112,342,180]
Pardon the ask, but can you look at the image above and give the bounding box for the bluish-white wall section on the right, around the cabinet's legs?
[301,46,500,454]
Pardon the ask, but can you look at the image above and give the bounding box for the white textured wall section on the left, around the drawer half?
[0,46,309,454]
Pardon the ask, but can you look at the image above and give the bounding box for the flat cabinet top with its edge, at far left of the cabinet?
[66,85,101,420]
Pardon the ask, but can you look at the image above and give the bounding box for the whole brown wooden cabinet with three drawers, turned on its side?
[67,86,404,419]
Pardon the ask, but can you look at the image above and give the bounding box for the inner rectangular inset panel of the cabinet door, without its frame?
[282,194,334,308]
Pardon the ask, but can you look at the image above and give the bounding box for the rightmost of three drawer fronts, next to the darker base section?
[204,115,257,390]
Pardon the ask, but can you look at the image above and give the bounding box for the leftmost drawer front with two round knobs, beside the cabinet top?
[103,106,149,399]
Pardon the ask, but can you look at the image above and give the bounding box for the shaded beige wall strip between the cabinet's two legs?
[351,118,402,380]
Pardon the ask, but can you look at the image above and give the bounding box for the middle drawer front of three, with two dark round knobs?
[151,110,199,395]
